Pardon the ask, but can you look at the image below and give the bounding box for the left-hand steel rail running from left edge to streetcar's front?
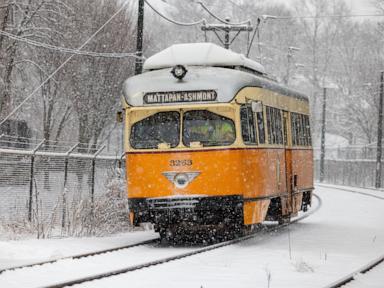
[0,238,160,274]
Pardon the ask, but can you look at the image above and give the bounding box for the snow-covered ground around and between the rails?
[0,186,384,288]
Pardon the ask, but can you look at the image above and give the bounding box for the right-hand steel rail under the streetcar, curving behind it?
[41,194,322,288]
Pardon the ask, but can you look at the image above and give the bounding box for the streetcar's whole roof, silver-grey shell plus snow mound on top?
[123,43,308,107]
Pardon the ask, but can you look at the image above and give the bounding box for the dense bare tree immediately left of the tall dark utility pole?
[64,0,135,151]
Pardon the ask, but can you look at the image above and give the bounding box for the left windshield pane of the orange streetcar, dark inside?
[130,111,180,149]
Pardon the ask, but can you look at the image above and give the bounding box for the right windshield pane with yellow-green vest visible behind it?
[183,110,236,147]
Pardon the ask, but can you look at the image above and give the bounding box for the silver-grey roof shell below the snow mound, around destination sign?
[123,66,308,106]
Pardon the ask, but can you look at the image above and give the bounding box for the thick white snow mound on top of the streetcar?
[144,43,265,74]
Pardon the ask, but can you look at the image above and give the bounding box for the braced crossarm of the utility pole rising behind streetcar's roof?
[201,18,253,49]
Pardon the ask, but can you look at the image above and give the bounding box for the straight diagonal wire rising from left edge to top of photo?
[0,1,129,126]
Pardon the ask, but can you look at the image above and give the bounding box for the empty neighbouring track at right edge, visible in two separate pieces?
[317,184,384,288]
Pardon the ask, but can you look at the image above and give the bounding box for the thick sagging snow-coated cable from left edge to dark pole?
[0,30,142,59]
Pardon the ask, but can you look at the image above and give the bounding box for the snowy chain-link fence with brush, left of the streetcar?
[0,135,129,237]
